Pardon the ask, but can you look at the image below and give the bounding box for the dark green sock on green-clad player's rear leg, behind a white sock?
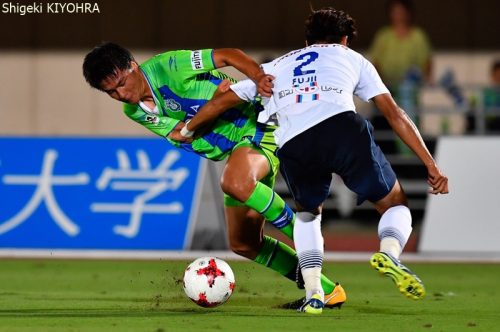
[254,235,335,294]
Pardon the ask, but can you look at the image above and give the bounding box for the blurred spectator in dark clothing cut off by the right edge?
[483,59,500,131]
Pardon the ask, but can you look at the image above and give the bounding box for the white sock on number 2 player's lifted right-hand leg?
[378,205,412,259]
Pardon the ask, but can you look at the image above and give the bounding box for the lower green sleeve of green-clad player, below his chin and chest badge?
[123,104,180,138]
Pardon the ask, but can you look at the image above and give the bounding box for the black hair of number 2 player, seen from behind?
[305,7,357,45]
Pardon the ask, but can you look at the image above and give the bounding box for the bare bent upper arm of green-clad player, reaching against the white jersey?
[213,48,273,97]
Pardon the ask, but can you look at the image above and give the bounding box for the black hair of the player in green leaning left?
[83,42,135,90]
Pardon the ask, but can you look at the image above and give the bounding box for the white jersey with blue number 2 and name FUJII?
[231,44,389,147]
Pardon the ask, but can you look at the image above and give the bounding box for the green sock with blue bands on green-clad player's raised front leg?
[245,182,295,239]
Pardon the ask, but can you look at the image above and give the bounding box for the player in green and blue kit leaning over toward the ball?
[83,43,346,306]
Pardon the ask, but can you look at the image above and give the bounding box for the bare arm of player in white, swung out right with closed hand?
[373,93,448,194]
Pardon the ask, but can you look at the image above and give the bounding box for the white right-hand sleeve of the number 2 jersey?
[354,57,389,101]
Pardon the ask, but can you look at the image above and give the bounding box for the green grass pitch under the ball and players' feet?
[0,260,500,332]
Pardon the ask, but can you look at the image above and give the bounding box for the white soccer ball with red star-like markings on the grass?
[184,257,235,308]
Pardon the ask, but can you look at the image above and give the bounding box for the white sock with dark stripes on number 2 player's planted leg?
[293,212,324,299]
